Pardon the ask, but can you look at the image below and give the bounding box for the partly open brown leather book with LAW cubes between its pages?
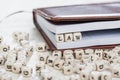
[33,2,120,50]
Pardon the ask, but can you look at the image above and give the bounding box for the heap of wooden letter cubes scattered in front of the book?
[0,32,120,80]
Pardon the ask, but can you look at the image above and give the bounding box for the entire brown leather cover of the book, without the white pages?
[33,2,120,51]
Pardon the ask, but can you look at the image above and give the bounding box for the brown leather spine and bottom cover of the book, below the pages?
[33,9,119,51]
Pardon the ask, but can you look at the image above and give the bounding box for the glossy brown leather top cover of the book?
[38,2,120,22]
